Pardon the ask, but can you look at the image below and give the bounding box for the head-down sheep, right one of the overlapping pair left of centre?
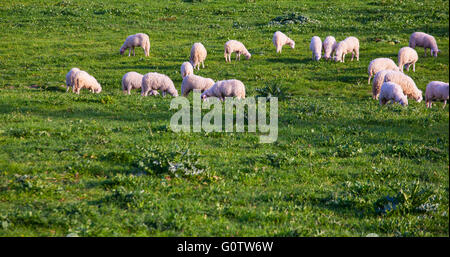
[141,72,178,97]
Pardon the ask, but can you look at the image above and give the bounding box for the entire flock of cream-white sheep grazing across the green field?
[66,31,449,108]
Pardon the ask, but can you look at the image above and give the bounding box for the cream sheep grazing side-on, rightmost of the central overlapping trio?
[201,79,245,101]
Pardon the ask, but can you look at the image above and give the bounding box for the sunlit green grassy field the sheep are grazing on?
[0,0,449,236]
